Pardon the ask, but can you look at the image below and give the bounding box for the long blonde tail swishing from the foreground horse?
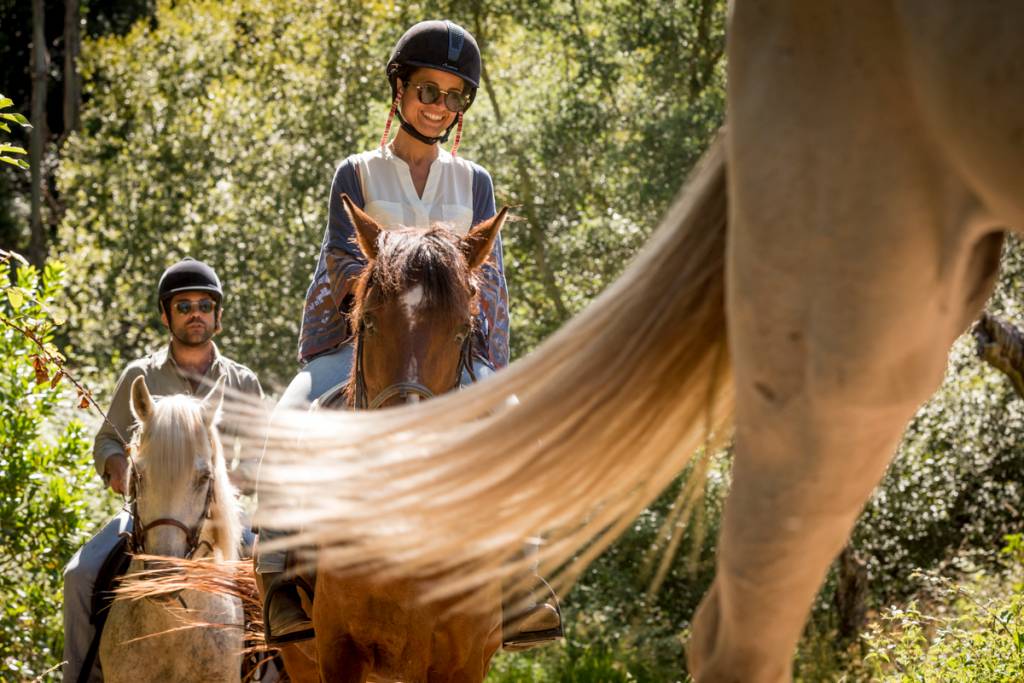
[251,134,732,593]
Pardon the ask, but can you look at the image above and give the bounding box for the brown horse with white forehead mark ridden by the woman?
[274,196,507,683]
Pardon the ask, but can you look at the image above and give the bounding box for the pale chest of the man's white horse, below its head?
[99,591,243,683]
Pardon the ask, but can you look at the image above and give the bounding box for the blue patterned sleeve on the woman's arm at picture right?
[473,165,509,370]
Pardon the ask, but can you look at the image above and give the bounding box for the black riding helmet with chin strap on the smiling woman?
[387,20,481,144]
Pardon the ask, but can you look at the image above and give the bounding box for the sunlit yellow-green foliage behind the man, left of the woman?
[59,0,387,386]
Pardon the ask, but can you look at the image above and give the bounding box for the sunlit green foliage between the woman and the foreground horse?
[450,0,725,355]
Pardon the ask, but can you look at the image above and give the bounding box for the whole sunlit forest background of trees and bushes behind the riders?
[0,0,1024,682]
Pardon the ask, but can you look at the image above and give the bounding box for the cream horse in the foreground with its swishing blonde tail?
[249,0,1024,681]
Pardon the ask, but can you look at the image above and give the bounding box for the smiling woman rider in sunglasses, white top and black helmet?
[256,20,561,648]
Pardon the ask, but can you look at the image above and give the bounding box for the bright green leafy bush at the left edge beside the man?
[0,254,105,679]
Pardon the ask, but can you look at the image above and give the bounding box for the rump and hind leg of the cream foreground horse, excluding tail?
[690,2,1000,681]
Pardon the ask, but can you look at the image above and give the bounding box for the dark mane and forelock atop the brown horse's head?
[350,224,477,330]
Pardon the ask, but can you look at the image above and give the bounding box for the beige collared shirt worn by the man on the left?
[92,344,263,475]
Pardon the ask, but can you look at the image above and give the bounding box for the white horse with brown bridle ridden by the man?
[99,377,243,683]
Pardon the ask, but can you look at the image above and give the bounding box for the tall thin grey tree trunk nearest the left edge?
[29,0,50,267]
